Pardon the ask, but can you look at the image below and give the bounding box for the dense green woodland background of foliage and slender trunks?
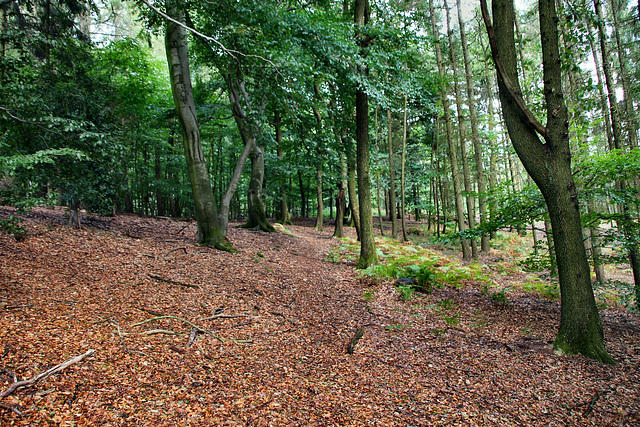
[0,0,640,359]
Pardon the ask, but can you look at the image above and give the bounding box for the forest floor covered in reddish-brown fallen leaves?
[0,208,640,427]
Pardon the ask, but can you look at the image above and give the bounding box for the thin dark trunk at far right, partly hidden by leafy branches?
[593,0,640,308]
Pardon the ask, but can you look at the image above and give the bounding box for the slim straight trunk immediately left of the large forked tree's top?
[456,0,489,253]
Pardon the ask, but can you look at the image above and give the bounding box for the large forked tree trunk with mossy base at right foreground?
[481,0,615,363]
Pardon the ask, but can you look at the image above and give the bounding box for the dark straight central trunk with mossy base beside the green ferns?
[354,0,378,269]
